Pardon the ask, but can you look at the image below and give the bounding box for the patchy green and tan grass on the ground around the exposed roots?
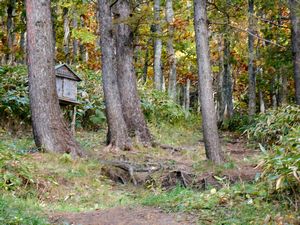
[0,124,300,225]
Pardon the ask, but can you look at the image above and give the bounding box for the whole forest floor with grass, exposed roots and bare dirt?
[0,126,295,224]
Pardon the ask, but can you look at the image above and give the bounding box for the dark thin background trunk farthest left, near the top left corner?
[6,0,16,64]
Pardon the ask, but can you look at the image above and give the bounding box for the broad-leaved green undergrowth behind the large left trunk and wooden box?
[0,66,106,130]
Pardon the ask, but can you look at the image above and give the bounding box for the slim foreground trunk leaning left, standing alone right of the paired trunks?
[194,0,222,164]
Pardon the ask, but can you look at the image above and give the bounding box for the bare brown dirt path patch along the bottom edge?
[50,207,195,225]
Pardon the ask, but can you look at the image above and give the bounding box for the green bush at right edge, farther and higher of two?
[246,106,300,147]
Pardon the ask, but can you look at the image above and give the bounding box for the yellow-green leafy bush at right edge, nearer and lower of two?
[262,126,300,199]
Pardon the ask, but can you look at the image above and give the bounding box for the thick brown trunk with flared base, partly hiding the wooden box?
[26,0,82,156]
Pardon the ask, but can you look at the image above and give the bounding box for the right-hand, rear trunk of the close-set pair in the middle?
[115,0,151,143]
